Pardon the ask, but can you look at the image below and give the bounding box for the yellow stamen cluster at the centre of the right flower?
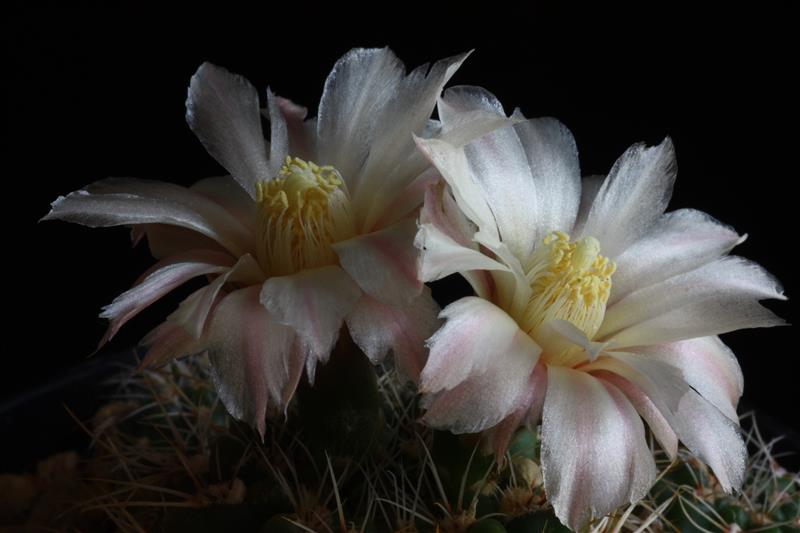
[522,232,616,339]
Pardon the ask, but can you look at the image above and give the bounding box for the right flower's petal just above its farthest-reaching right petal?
[608,209,744,305]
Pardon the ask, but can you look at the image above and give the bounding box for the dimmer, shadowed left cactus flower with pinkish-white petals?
[44,49,497,433]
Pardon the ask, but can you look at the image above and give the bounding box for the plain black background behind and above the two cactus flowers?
[0,2,800,448]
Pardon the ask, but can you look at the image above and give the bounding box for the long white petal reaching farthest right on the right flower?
[597,256,786,347]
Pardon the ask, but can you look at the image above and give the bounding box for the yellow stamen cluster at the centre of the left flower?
[256,156,354,276]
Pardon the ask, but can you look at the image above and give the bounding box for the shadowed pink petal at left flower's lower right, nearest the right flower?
[346,287,440,382]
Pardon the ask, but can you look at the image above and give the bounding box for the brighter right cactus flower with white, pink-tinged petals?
[417,98,784,529]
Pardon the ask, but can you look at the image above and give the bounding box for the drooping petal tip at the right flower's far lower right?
[675,391,747,492]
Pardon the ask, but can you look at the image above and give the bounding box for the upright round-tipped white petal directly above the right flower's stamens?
[514,118,581,236]
